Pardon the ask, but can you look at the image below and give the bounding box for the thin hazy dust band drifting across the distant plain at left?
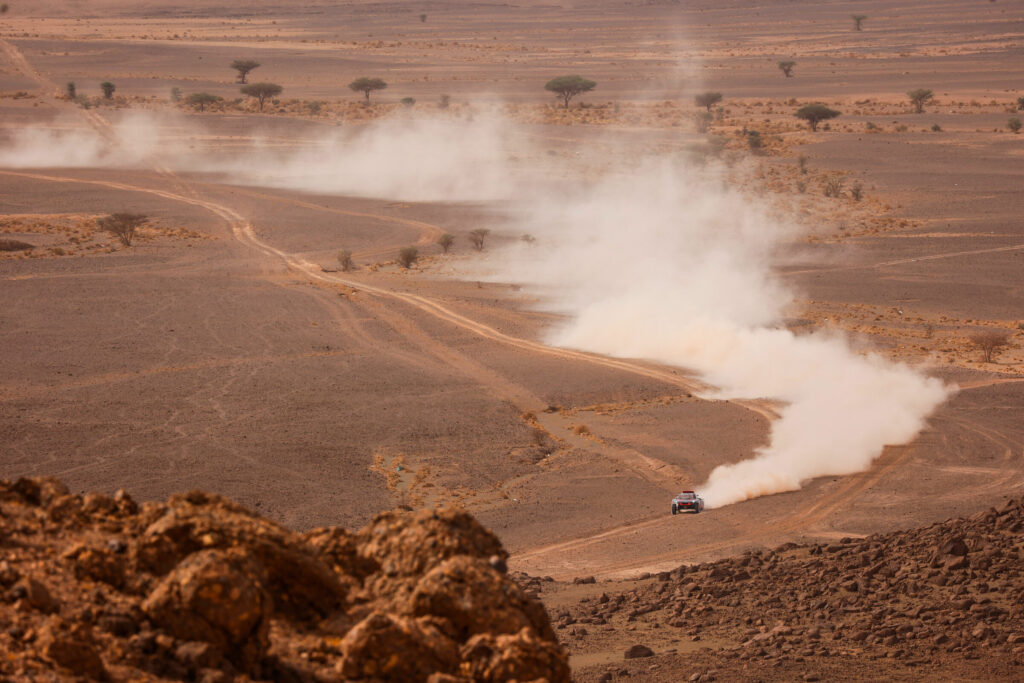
[0,112,525,201]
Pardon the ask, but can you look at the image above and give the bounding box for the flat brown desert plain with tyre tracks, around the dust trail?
[0,0,1024,680]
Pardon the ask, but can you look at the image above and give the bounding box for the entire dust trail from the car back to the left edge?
[0,108,952,507]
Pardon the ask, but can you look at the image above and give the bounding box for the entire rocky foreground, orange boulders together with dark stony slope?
[8,479,1024,683]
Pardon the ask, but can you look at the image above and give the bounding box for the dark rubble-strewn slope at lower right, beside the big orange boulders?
[540,493,1024,681]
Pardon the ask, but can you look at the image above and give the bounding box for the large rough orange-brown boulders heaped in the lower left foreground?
[0,479,569,683]
